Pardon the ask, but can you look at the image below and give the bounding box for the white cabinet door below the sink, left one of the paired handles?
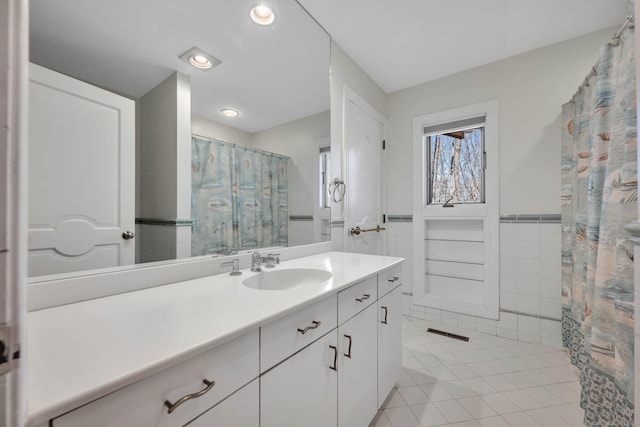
[260,329,339,427]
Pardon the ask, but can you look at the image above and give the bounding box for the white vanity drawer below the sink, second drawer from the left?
[260,295,338,373]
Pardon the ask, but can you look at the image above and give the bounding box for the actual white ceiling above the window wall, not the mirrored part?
[298,0,628,93]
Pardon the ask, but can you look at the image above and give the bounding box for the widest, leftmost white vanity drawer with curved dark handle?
[52,330,259,427]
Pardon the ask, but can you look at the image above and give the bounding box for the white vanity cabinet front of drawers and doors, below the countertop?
[45,260,402,427]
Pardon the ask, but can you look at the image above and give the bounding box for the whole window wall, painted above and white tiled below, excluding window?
[385,28,618,347]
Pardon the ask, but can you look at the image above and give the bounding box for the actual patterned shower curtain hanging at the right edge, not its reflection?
[561,15,638,427]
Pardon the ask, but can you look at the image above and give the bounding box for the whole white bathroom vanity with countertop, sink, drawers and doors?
[26,252,403,427]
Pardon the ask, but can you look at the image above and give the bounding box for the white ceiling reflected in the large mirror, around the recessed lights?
[29,0,330,132]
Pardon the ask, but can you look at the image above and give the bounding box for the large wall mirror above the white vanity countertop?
[29,0,331,282]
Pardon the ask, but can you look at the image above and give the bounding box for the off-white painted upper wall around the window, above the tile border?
[384,28,617,214]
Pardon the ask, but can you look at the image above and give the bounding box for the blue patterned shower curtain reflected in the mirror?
[191,136,289,256]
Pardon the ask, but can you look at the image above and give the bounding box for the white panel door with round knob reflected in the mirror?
[28,64,135,276]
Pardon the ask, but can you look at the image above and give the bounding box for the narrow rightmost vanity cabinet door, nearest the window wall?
[378,286,402,407]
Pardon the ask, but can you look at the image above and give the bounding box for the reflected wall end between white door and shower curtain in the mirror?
[136,72,191,262]
